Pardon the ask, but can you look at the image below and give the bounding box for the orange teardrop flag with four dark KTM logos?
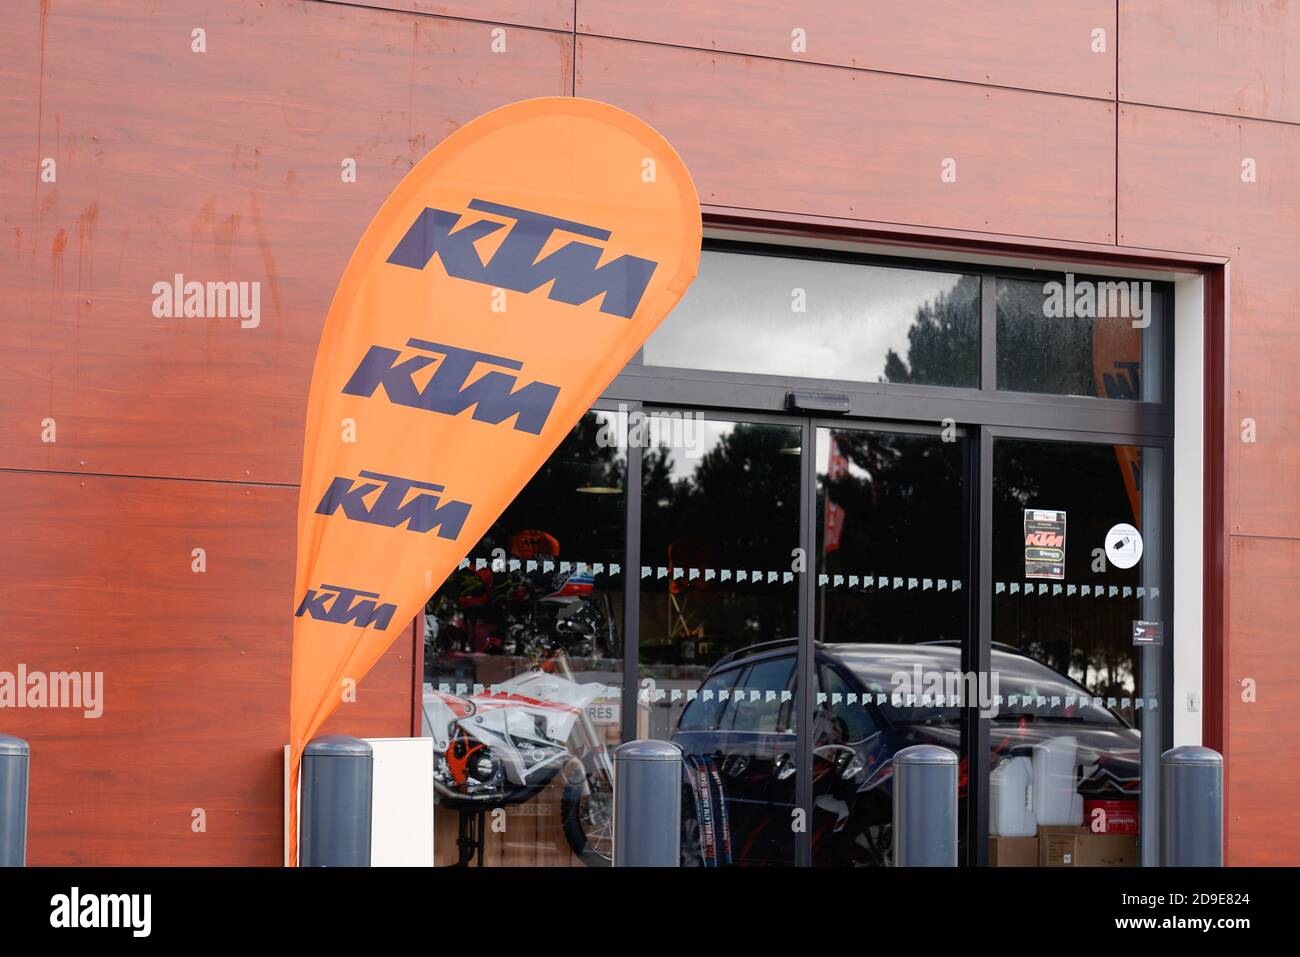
[289,98,701,861]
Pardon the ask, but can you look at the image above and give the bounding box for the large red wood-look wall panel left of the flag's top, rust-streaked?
[0,0,572,482]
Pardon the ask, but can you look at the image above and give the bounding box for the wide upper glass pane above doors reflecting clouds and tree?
[645,250,980,387]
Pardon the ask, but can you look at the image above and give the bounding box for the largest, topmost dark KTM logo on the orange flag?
[387,199,658,319]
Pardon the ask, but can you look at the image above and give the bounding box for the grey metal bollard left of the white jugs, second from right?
[893,744,957,867]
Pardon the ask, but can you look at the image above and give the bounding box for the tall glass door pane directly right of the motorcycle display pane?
[636,417,801,867]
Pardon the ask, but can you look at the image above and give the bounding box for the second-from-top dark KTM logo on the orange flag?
[343,339,560,436]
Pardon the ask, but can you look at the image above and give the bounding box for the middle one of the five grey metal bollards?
[614,741,681,867]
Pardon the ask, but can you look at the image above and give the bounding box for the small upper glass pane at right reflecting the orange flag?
[997,274,1164,402]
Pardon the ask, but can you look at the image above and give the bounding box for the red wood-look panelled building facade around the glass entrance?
[0,0,1300,865]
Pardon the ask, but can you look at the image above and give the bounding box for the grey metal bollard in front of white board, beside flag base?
[300,735,374,867]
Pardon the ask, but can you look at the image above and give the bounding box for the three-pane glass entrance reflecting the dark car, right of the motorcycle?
[628,416,1171,866]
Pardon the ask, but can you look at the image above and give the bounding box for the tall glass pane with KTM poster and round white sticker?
[989,439,1166,866]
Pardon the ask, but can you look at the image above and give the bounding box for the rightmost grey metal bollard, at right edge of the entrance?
[1160,746,1223,867]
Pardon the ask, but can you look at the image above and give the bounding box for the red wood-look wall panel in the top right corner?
[1119,0,1300,122]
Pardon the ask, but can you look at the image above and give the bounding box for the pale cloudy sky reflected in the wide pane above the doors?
[645,250,961,382]
